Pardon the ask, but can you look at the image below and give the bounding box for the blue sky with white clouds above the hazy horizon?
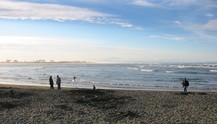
[0,0,217,63]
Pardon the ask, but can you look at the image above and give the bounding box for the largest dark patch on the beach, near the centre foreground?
[71,89,140,122]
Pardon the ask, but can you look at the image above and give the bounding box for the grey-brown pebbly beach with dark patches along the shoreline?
[0,85,217,124]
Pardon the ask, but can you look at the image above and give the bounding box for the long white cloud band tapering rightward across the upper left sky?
[0,0,132,27]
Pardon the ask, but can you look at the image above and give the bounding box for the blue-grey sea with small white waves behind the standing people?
[0,63,217,92]
